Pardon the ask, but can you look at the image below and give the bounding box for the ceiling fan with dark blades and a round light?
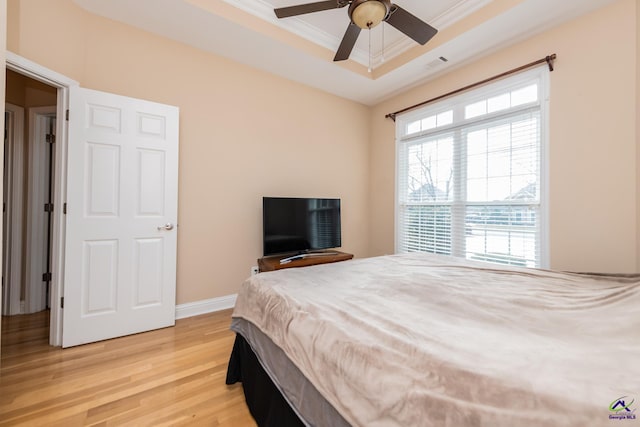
[274,0,438,61]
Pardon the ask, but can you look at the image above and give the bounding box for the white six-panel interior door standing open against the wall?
[62,88,178,347]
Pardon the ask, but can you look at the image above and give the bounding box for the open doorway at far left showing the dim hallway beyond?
[2,70,58,338]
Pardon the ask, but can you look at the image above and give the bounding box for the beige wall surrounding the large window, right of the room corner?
[370,0,638,272]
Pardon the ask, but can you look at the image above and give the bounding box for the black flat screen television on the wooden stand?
[262,197,342,256]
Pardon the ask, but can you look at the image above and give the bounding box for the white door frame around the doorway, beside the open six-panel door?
[5,51,80,346]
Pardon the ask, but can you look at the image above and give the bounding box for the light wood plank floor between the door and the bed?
[0,310,255,427]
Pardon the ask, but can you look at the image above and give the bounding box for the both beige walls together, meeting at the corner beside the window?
[5,0,640,314]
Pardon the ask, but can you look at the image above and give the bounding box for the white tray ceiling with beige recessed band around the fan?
[74,0,615,105]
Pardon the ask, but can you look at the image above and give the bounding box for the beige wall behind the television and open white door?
[7,0,369,304]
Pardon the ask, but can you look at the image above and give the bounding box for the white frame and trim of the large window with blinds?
[394,65,550,268]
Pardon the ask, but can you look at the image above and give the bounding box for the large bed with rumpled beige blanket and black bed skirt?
[227,254,640,427]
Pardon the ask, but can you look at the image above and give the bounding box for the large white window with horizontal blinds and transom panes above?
[396,67,548,267]
